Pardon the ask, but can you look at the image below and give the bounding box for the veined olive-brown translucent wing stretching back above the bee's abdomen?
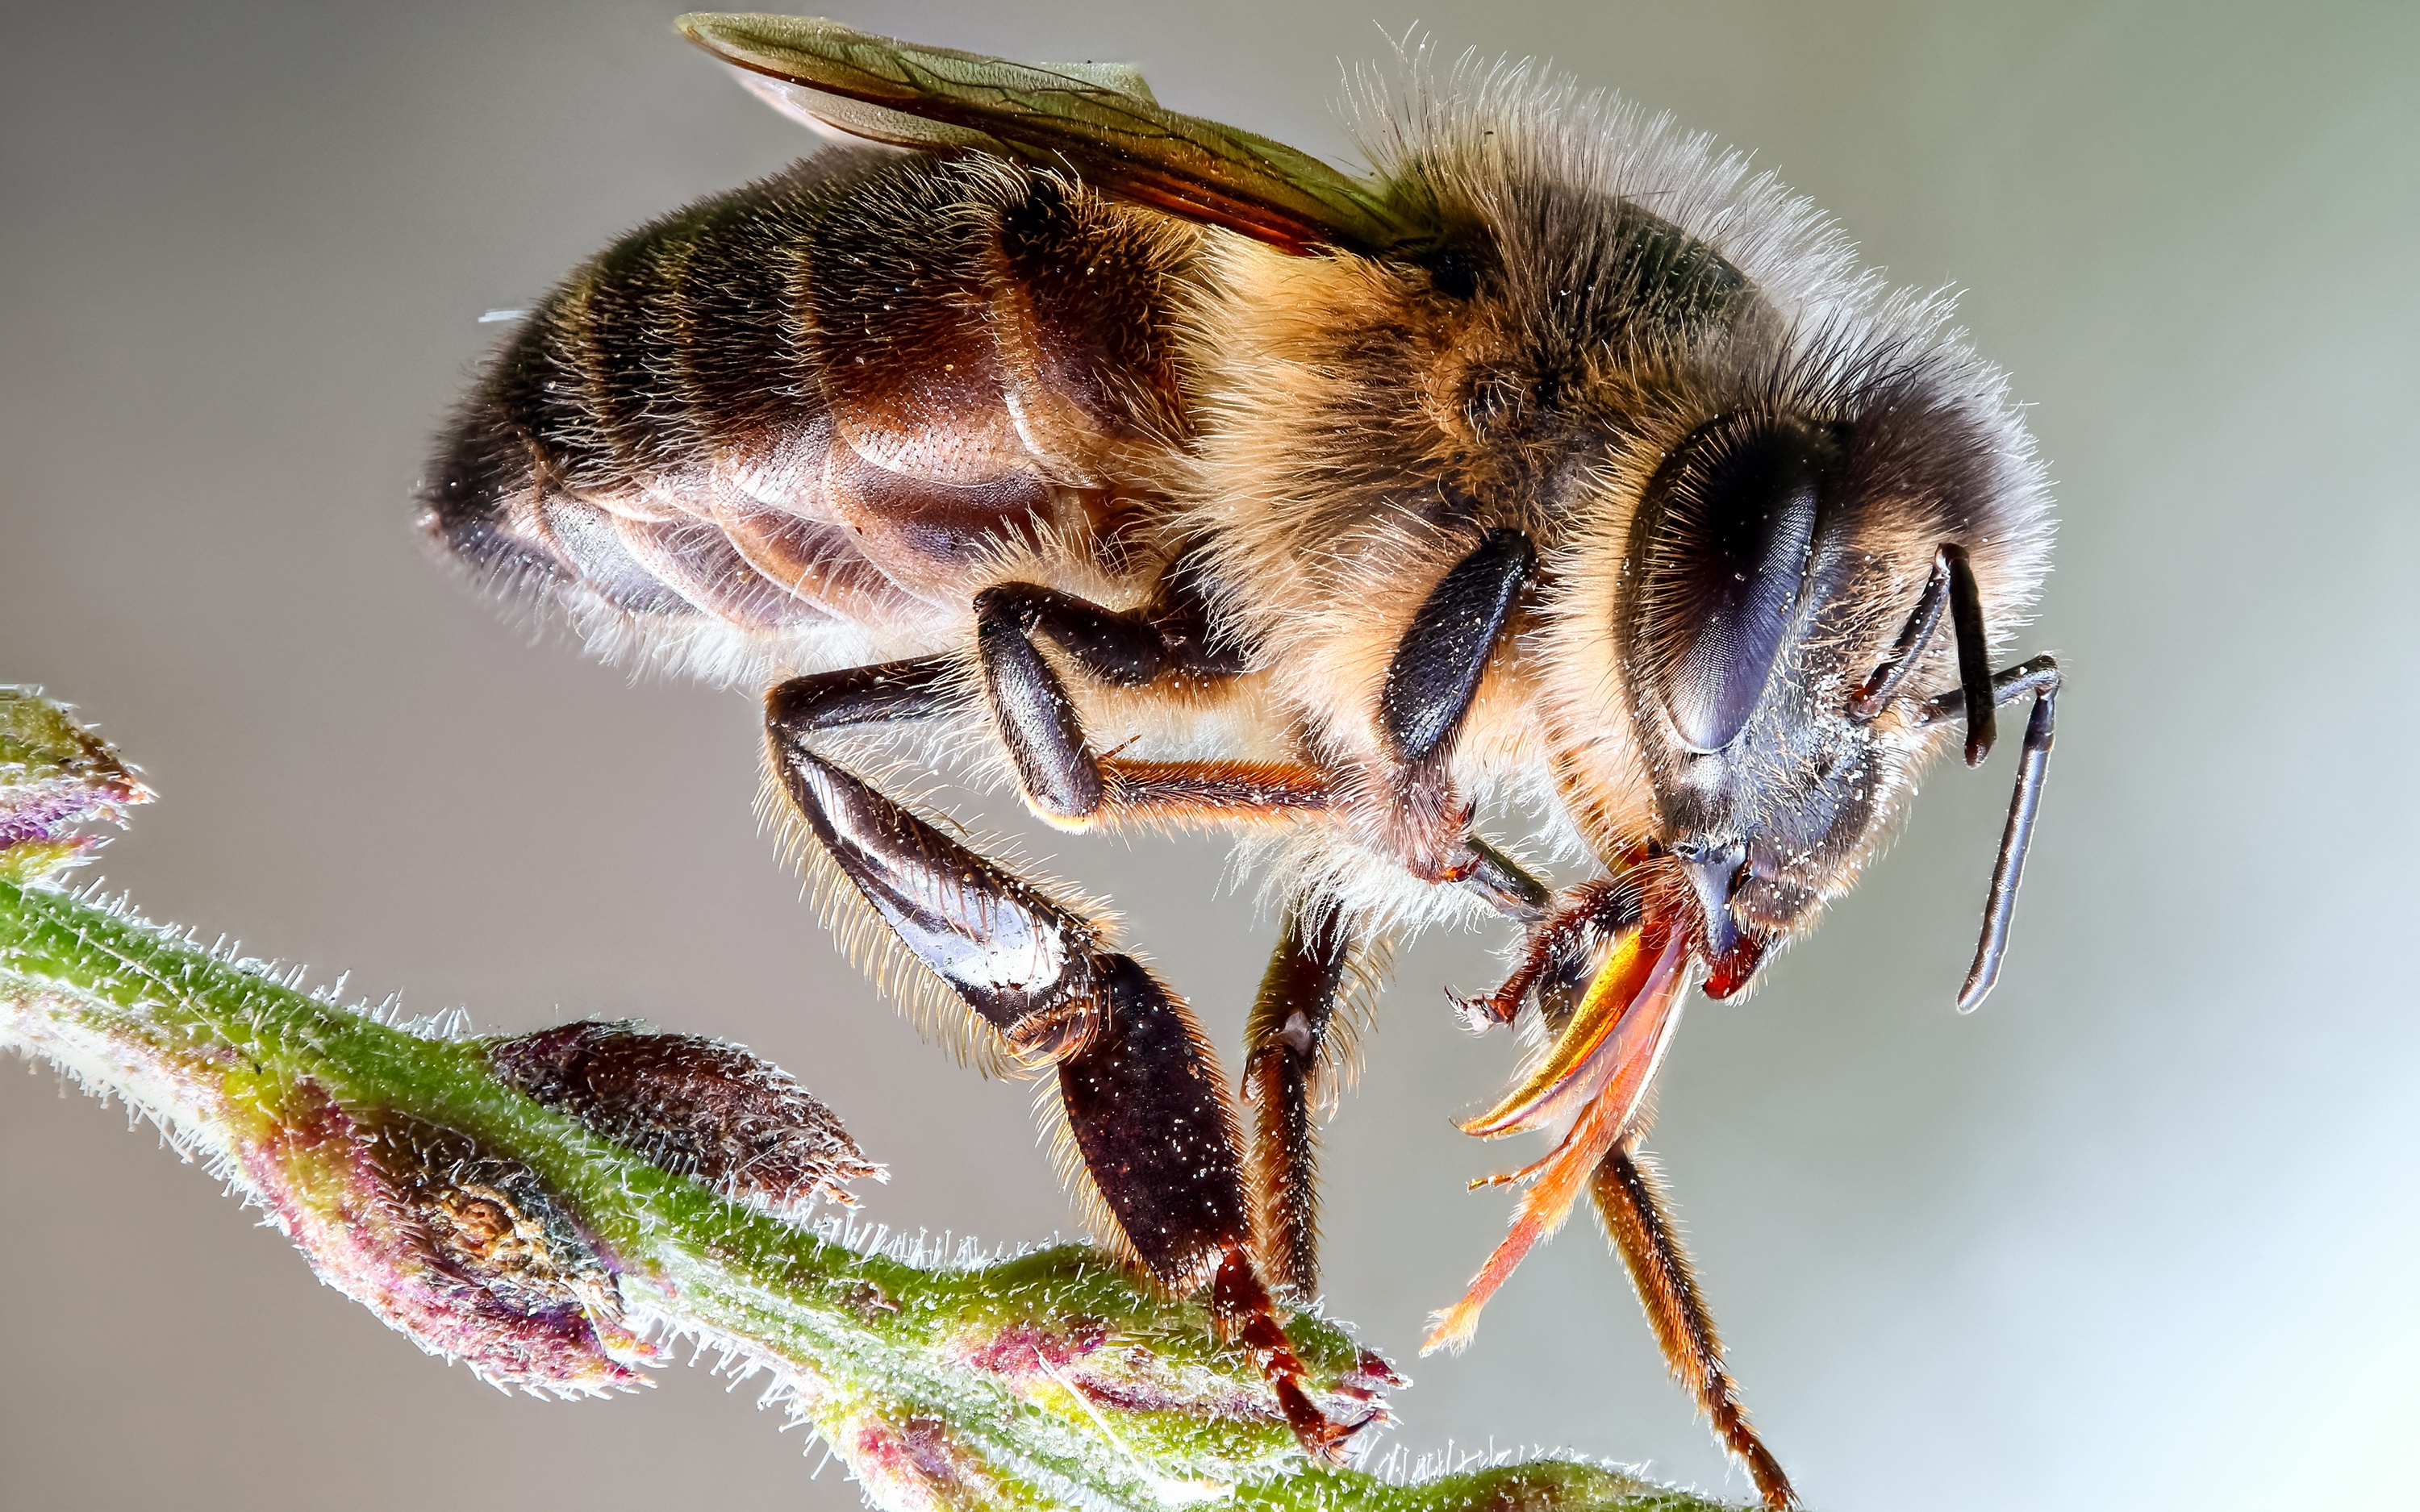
[680,15,1421,252]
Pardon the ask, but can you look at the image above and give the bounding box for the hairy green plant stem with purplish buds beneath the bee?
[0,689,1742,1512]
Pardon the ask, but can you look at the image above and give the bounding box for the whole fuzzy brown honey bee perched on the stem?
[421,15,2059,1507]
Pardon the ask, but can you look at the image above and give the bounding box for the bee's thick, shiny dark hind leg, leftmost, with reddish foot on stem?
[765,658,1360,1461]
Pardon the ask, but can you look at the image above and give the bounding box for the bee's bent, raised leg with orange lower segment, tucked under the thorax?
[975,583,1326,827]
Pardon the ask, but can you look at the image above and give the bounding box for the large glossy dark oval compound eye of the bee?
[1634,416,1820,750]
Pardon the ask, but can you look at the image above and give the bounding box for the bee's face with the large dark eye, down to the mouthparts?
[1619,411,1924,958]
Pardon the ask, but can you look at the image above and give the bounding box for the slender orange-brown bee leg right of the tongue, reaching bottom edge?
[1588,1142,1798,1510]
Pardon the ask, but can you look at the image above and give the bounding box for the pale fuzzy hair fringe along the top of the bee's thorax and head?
[1343,39,2052,602]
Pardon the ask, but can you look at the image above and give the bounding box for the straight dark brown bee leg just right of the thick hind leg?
[1244,902,1353,1302]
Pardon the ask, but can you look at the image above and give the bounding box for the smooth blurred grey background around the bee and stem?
[0,0,2420,1512]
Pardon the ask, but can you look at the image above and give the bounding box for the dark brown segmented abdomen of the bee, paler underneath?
[421,152,1198,675]
